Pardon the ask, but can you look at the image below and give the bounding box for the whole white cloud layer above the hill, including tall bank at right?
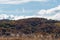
[0,5,60,20]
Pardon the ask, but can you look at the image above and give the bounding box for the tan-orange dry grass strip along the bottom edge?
[0,35,60,40]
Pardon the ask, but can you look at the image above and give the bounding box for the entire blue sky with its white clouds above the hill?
[0,0,60,20]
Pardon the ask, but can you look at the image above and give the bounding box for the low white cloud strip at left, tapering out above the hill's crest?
[0,14,39,20]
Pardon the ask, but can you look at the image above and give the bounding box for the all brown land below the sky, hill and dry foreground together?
[0,18,60,40]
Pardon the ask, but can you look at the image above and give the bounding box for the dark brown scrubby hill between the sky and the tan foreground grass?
[0,18,60,36]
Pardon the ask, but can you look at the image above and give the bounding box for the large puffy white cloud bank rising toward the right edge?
[37,5,60,20]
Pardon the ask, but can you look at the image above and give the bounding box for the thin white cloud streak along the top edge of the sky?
[0,0,48,4]
